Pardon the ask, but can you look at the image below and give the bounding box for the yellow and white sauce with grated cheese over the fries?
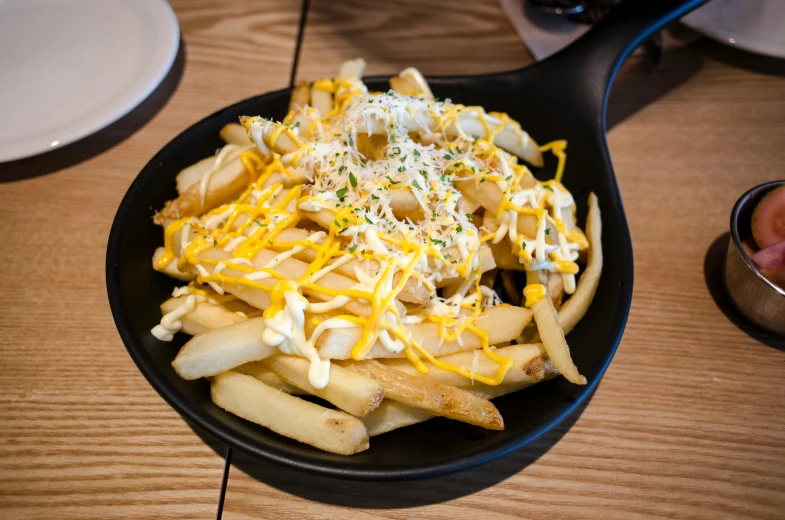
[153,78,587,388]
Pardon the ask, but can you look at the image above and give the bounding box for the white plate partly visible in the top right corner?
[682,0,785,58]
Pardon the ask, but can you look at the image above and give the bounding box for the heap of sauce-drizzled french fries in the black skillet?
[153,60,602,455]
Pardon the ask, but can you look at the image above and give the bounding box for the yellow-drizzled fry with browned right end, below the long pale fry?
[384,344,547,387]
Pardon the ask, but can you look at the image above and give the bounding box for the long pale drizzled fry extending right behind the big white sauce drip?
[316,305,532,359]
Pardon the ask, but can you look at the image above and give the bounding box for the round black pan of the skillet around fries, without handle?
[107,79,632,480]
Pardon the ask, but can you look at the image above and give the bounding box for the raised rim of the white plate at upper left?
[0,0,180,164]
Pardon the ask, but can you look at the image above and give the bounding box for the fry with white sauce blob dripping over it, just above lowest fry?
[264,355,384,416]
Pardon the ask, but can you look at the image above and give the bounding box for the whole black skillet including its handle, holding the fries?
[106,0,702,480]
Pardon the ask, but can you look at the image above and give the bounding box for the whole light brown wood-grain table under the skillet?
[0,0,785,519]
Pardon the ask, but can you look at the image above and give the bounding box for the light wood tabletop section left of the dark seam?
[0,0,300,520]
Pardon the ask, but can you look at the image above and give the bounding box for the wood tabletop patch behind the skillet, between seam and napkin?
[298,0,531,79]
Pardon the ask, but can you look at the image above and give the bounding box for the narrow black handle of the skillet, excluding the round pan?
[554,0,707,113]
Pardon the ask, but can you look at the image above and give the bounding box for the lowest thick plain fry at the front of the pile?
[210,371,369,455]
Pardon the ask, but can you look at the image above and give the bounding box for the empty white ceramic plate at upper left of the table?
[0,0,180,162]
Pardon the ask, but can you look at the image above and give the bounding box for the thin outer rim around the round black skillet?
[106,81,634,482]
